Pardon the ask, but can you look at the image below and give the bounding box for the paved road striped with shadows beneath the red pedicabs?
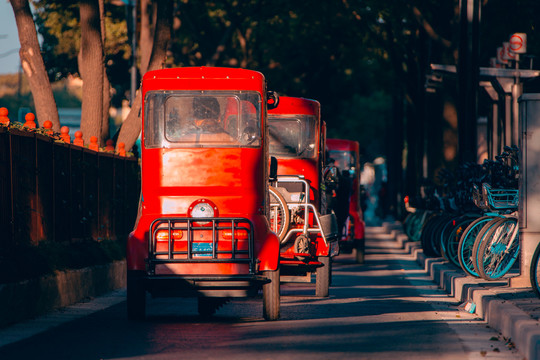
[0,229,523,360]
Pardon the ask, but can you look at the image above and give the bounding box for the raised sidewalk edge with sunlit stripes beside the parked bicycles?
[366,222,540,360]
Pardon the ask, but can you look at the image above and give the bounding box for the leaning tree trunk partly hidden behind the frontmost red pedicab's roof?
[116,0,173,150]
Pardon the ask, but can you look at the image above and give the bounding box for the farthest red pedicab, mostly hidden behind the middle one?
[326,139,365,263]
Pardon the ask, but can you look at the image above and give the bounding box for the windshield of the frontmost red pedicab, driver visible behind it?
[144,91,261,148]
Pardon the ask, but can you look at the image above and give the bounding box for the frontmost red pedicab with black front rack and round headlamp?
[127,67,280,320]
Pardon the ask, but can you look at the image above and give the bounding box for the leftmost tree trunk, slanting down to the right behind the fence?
[10,0,60,132]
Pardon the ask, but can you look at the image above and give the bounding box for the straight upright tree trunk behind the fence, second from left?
[79,0,105,144]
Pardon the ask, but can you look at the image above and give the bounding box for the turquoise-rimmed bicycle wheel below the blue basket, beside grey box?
[478,217,519,280]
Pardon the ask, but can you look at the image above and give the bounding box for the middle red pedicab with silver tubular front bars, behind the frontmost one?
[268,96,339,296]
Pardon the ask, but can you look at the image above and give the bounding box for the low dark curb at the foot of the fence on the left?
[0,261,126,327]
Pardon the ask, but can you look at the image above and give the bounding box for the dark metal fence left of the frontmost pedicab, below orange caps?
[0,127,140,252]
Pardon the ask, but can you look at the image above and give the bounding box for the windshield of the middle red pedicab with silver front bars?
[268,115,318,158]
